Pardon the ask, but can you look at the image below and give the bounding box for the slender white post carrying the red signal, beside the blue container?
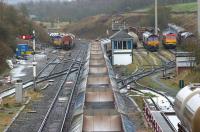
[33,30,37,91]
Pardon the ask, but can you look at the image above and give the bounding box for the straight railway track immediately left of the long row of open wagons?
[38,51,85,132]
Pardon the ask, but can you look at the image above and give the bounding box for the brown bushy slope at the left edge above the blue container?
[0,2,48,73]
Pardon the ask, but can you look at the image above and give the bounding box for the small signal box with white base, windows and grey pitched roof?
[110,30,134,65]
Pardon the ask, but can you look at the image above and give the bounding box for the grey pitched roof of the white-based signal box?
[110,30,133,40]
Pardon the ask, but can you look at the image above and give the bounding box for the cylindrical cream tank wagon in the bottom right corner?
[174,83,200,132]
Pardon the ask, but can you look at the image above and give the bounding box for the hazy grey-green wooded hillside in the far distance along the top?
[25,0,196,21]
